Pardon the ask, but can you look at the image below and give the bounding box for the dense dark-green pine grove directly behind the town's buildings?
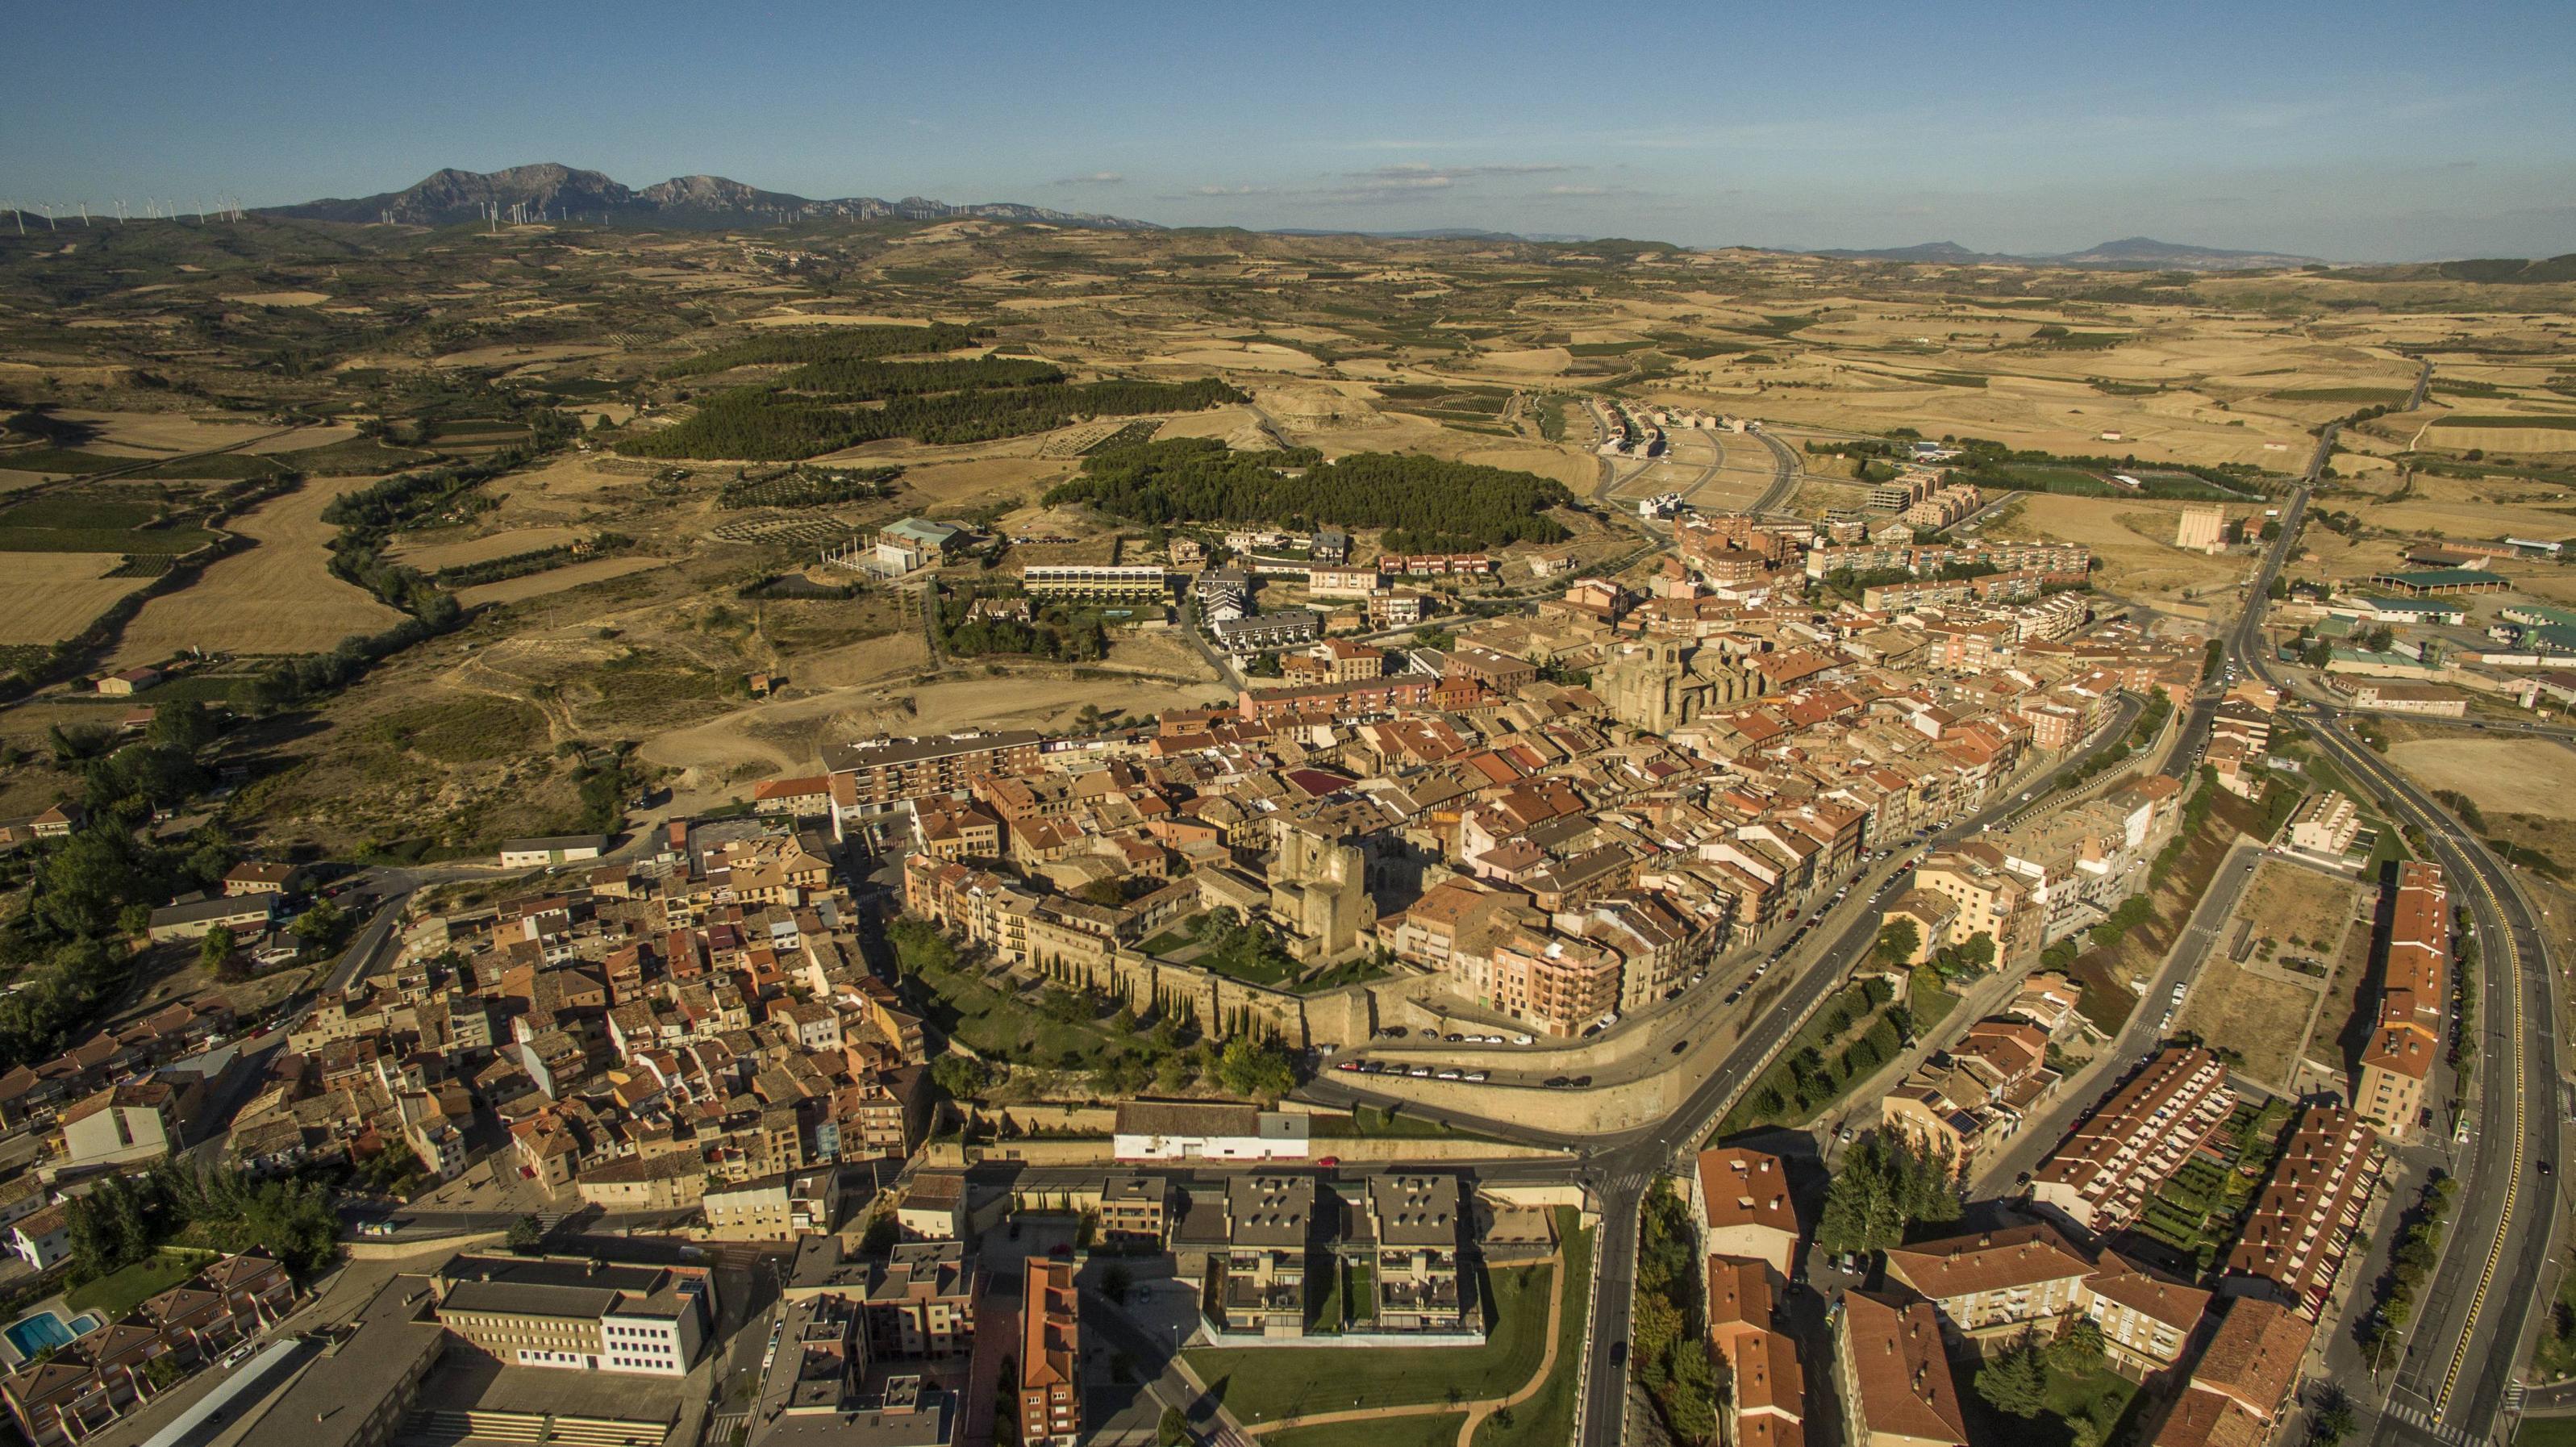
[1046,438,1574,551]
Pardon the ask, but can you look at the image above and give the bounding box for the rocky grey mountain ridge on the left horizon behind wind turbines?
[263,162,1161,231]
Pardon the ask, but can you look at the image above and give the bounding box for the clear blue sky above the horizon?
[0,0,2576,260]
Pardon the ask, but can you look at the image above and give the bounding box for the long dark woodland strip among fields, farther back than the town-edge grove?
[619,378,1244,461]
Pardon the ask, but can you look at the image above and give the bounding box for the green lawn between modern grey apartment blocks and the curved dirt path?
[1187,1267,1545,1442]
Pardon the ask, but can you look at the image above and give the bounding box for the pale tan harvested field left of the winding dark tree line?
[116,477,402,667]
